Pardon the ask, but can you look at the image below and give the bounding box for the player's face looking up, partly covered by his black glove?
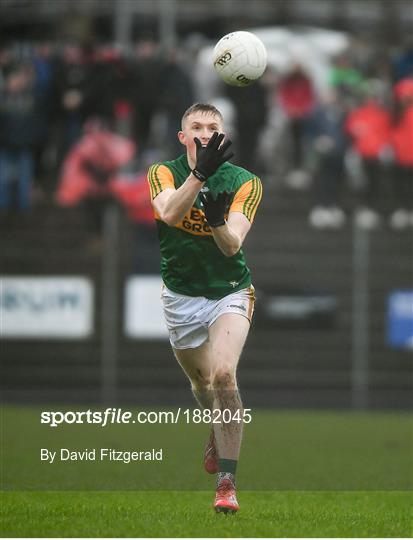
[178,111,223,162]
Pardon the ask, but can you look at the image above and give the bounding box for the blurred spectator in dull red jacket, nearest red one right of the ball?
[277,64,315,187]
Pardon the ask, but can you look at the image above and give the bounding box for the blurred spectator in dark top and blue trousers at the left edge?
[0,63,45,212]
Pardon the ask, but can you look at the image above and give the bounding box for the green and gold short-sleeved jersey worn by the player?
[148,155,262,299]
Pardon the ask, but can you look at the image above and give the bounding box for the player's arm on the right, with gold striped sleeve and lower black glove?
[201,178,262,257]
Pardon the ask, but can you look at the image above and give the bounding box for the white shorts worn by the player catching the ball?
[161,285,255,349]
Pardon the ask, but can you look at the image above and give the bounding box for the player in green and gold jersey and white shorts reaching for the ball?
[148,103,262,513]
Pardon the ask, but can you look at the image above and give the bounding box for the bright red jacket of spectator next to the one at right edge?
[345,101,391,159]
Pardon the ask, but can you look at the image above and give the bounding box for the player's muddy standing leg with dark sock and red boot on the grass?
[209,313,250,513]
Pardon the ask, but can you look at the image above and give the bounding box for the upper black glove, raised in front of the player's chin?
[192,131,234,182]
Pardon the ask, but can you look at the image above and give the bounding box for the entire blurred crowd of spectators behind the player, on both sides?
[0,34,413,238]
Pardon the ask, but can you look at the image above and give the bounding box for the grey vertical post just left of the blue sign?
[351,223,370,409]
